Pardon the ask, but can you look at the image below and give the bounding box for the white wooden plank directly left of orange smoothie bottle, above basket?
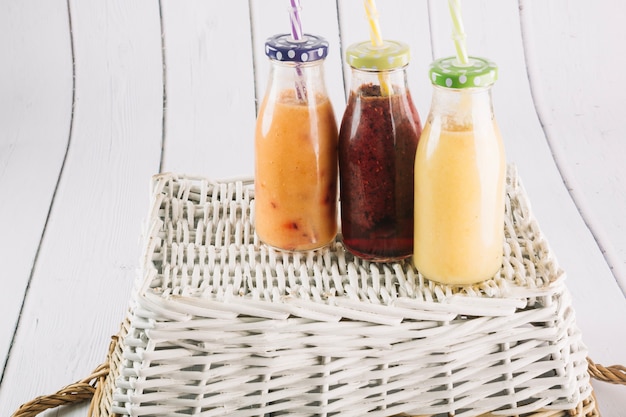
[162,0,256,179]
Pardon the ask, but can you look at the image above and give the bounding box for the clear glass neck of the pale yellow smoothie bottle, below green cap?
[430,86,494,130]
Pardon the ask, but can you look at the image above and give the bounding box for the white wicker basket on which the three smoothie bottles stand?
[112,167,592,417]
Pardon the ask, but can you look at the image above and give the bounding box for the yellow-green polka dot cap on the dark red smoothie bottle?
[346,40,410,71]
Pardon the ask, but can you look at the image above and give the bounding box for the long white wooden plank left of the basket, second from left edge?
[0,0,162,415]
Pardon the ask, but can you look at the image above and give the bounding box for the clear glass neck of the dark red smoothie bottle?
[350,66,408,96]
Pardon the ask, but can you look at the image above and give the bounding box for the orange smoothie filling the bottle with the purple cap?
[255,90,338,251]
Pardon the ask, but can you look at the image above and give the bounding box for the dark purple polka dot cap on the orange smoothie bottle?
[265,33,328,63]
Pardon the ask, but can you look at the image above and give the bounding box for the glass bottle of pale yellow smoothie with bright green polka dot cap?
[413,57,506,284]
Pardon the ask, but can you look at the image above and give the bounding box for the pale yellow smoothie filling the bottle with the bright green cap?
[413,118,505,284]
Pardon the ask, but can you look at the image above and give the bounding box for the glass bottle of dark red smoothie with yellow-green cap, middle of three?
[339,40,422,262]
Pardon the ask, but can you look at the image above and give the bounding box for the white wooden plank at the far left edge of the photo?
[0,0,72,366]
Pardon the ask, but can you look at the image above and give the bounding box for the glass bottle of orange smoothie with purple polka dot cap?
[254,34,338,251]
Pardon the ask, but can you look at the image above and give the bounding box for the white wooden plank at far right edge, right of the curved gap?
[521,0,626,294]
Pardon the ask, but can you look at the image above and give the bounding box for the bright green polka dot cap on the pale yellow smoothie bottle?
[428,57,498,88]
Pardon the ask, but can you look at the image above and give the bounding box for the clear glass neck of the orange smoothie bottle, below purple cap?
[267,59,328,102]
